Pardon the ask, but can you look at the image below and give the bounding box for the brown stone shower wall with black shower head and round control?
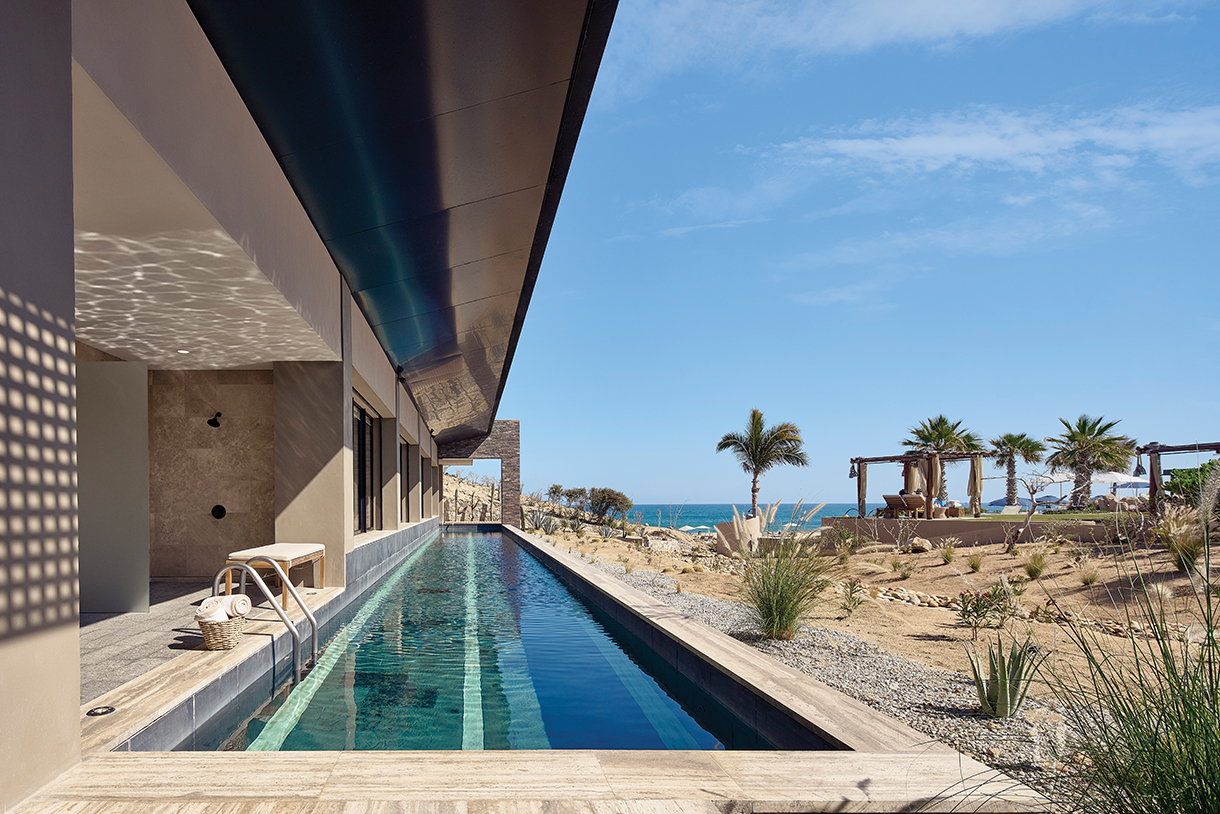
[146,362,274,578]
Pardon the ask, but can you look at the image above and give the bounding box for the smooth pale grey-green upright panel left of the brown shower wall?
[77,361,149,614]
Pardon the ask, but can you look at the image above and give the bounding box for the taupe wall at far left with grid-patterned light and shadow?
[0,0,81,810]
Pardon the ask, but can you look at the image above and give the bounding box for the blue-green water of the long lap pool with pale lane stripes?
[224,533,770,751]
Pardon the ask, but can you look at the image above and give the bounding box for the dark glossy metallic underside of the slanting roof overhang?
[188,0,616,442]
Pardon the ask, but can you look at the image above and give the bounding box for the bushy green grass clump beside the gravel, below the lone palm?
[743,536,832,638]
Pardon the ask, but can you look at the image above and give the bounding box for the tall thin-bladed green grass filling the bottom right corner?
[1043,471,1220,814]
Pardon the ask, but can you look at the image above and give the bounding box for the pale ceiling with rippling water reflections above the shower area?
[72,61,338,370]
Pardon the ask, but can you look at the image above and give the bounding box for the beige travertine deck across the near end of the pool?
[13,751,1041,814]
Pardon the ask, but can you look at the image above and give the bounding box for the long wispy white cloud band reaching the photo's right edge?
[775,105,1220,184]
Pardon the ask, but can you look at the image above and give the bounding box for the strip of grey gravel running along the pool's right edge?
[595,561,1078,794]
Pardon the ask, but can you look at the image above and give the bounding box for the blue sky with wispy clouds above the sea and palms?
[498,0,1220,504]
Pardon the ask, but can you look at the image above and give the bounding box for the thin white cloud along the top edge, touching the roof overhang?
[598,0,1192,99]
